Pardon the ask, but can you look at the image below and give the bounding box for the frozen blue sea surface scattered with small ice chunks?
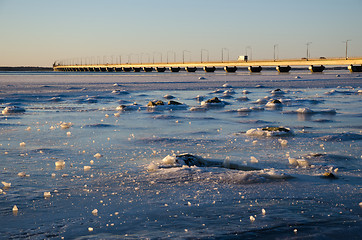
[0,72,362,239]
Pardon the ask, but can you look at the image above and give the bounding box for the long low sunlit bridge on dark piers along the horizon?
[53,58,362,72]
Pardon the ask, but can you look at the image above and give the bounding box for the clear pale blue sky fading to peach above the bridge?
[0,0,362,66]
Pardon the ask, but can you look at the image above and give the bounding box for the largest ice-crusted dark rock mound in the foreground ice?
[147,153,291,184]
